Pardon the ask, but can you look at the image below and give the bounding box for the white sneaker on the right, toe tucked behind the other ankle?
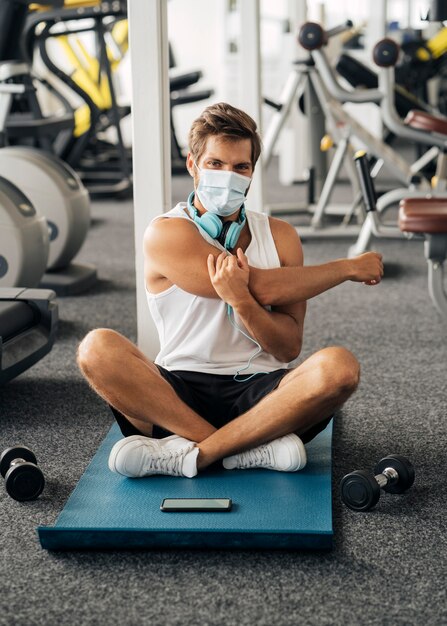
[223,434,307,472]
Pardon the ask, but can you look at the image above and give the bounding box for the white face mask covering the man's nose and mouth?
[194,163,251,217]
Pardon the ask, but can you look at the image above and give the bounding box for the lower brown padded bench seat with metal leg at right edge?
[399,198,447,319]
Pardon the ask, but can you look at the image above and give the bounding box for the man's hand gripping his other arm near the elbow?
[207,248,252,309]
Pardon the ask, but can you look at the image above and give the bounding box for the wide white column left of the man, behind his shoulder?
[128,0,171,359]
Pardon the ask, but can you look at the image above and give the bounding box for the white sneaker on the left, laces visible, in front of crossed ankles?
[109,435,199,478]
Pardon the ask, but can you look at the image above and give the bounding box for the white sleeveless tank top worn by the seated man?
[146,202,289,376]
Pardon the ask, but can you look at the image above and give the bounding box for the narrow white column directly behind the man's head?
[239,0,264,212]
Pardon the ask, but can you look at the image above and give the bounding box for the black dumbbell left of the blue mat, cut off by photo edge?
[0,446,45,502]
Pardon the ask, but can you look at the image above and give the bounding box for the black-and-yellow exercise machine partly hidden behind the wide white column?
[22,0,213,188]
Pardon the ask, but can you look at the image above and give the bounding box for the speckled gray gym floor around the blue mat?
[0,162,447,626]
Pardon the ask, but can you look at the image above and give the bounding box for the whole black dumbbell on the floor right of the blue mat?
[340,454,414,511]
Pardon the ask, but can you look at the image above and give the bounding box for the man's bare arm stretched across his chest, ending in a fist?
[144,218,383,306]
